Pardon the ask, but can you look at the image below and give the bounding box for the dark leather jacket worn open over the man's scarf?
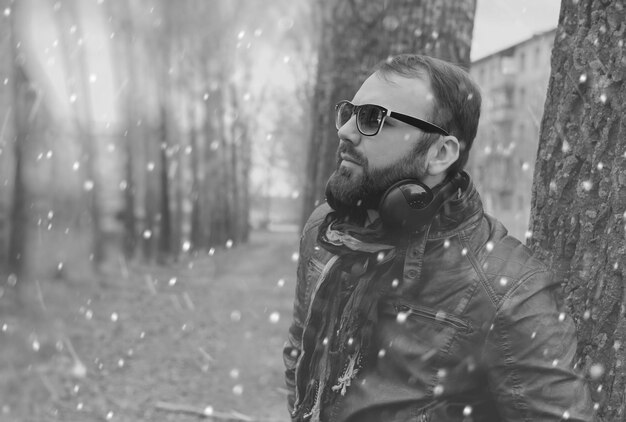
[283,176,594,422]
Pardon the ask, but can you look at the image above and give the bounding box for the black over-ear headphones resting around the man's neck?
[378,172,469,232]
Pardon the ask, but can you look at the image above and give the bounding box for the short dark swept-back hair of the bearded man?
[374,54,481,174]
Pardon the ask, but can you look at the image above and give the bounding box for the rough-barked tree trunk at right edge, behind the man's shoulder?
[529,0,626,421]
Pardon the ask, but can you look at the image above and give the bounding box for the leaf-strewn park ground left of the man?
[0,232,298,422]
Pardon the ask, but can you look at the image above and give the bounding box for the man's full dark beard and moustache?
[326,140,430,215]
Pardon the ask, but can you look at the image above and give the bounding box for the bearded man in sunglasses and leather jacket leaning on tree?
[284,55,594,422]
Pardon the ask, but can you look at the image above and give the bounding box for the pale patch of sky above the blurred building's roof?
[471,0,561,61]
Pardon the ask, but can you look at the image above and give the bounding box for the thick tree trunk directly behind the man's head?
[302,0,476,227]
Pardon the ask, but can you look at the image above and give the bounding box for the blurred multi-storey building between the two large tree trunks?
[468,29,556,239]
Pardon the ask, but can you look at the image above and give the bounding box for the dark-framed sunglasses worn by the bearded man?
[335,100,448,136]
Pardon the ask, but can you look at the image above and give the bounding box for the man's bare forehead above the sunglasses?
[352,73,433,114]
